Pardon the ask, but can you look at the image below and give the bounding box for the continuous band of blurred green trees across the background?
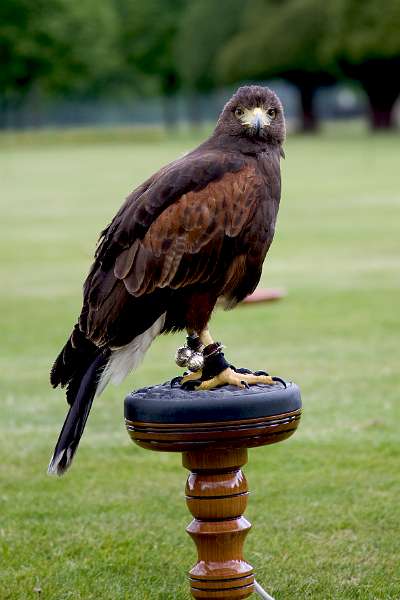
[0,0,400,129]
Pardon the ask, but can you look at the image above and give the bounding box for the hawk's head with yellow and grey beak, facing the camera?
[216,85,286,144]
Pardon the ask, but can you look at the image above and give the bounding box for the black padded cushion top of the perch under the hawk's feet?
[125,382,301,423]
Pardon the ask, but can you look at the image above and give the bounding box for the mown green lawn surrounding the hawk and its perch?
[0,127,400,600]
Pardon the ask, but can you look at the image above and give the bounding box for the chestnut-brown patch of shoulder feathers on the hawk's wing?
[114,167,261,296]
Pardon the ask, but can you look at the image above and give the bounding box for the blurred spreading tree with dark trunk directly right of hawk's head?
[219,0,334,131]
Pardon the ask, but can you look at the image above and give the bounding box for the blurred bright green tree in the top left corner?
[0,0,117,123]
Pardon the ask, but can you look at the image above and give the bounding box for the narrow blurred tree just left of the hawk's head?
[176,0,243,123]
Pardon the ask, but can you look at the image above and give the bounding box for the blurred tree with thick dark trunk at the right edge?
[325,0,400,129]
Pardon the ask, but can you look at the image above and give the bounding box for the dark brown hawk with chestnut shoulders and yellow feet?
[49,86,285,475]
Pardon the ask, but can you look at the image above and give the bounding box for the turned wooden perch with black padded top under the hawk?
[125,383,301,600]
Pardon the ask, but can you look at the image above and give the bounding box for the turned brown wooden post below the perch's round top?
[183,448,254,600]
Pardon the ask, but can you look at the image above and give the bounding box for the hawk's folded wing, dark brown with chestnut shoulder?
[80,156,266,344]
